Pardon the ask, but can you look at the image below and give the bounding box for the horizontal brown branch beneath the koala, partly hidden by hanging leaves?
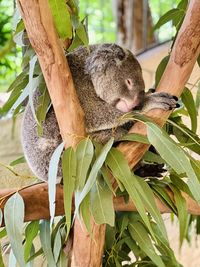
[0,183,200,224]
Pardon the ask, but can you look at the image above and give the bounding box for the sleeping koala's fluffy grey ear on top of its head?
[85,44,126,75]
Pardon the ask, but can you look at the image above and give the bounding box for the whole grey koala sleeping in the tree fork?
[22,44,177,180]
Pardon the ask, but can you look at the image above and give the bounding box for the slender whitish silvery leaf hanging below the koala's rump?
[48,142,64,224]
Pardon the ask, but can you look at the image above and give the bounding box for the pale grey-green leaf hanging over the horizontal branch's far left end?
[4,193,25,267]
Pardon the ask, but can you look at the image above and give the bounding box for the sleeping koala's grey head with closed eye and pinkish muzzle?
[85,44,144,112]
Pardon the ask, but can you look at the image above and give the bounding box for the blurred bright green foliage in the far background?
[0,0,184,92]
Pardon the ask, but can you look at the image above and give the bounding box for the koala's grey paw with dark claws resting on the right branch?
[142,92,180,112]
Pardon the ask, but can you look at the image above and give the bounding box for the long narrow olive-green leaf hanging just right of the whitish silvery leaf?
[62,147,77,238]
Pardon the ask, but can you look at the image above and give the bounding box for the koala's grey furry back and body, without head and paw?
[22,46,125,180]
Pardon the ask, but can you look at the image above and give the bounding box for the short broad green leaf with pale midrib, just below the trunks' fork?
[76,138,94,189]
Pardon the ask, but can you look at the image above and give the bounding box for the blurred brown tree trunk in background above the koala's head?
[113,0,155,53]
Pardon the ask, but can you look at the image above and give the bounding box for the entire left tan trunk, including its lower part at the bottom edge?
[18,0,105,267]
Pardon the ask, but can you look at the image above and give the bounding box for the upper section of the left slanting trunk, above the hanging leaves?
[18,0,85,147]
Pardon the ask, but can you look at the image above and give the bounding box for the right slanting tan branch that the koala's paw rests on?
[118,0,200,168]
